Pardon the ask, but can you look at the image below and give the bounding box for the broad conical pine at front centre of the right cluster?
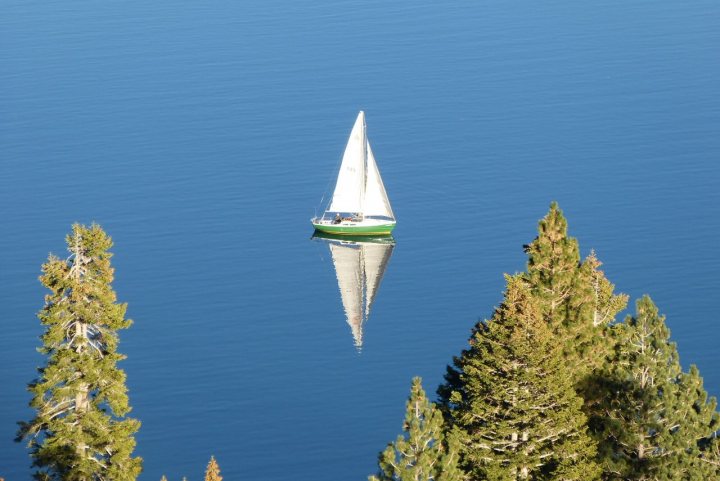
[439,276,599,481]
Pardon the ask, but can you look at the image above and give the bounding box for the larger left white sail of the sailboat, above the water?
[328,111,367,212]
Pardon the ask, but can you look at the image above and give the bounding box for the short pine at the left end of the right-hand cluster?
[369,377,462,481]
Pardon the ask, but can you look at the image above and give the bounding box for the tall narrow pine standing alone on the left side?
[18,224,142,481]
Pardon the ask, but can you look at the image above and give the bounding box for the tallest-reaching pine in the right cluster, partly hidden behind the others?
[523,202,627,382]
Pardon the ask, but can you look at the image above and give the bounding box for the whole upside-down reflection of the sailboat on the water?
[312,231,395,350]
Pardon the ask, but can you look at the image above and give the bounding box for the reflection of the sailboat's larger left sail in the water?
[330,243,365,347]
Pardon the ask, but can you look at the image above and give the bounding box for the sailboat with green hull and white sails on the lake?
[311,111,395,235]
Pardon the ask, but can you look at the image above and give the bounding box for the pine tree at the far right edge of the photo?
[591,296,718,481]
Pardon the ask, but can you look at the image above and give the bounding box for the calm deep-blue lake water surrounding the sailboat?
[0,0,720,481]
